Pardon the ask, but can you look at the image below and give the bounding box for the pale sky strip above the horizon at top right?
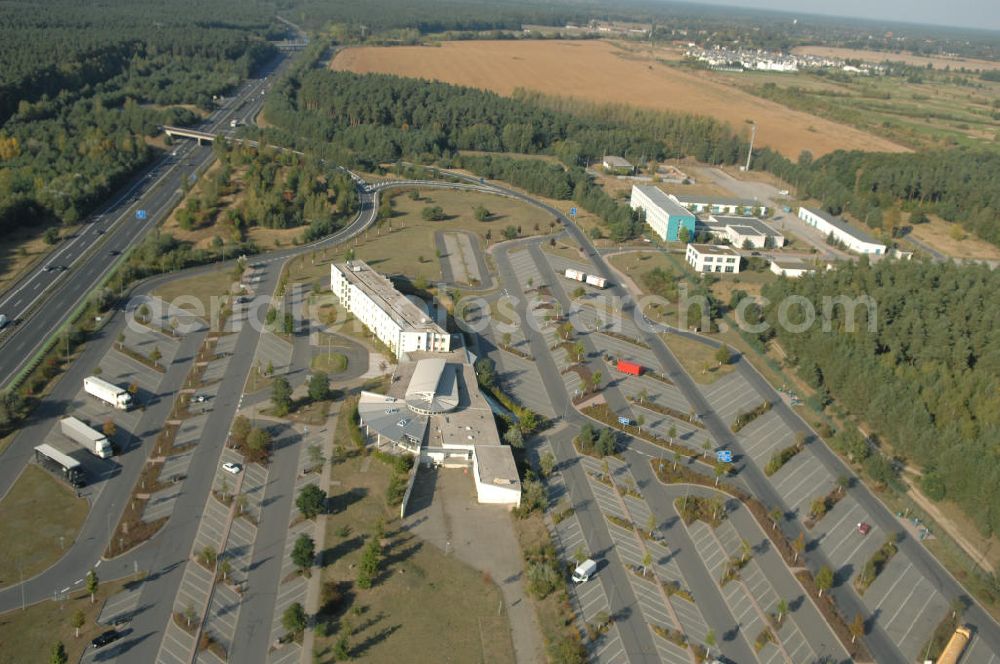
[694,0,1000,30]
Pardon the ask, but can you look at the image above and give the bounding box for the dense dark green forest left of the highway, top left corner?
[0,0,286,232]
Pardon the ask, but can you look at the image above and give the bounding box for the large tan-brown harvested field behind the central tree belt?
[331,41,906,159]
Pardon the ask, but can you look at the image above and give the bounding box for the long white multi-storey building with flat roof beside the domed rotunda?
[330,261,451,357]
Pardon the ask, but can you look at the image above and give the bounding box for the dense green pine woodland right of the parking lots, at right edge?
[764,260,1000,534]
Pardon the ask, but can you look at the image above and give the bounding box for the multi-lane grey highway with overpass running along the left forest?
[0,55,286,388]
